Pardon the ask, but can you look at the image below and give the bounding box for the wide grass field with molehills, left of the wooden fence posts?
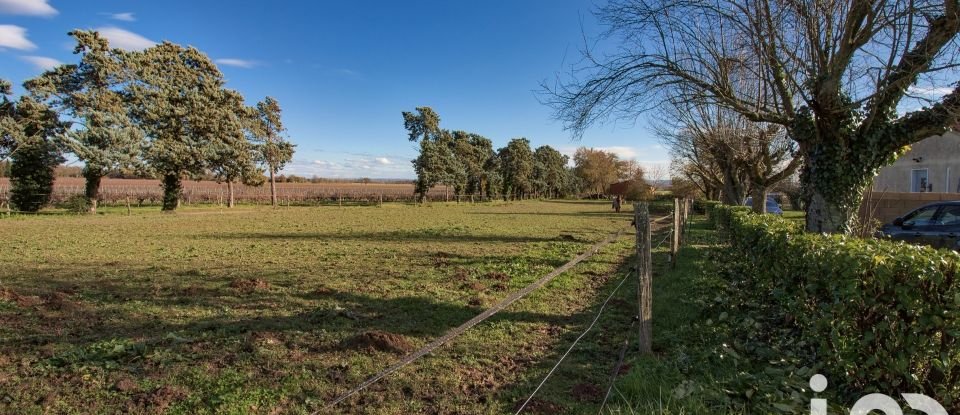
[0,201,668,414]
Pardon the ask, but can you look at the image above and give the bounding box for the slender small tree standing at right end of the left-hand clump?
[251,97,296,206]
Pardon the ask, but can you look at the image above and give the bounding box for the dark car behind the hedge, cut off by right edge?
[878,201,960,249]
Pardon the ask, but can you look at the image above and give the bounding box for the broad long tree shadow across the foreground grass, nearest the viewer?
[0,274,556,352]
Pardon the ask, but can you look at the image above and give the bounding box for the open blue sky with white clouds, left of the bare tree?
[0,0,668,178]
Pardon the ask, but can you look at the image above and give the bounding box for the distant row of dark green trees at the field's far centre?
[402,107,649,200]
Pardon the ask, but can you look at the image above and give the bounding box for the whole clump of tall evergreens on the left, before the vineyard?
[0,30,294,212]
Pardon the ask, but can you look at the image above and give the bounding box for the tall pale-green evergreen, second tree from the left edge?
[25,30,144,213]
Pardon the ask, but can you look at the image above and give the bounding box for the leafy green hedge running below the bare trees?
[710,206,960,413]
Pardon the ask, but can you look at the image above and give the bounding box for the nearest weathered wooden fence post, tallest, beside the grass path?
[633,203,653,354]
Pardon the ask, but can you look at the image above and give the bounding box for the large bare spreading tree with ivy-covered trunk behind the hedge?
[544,0,960,232]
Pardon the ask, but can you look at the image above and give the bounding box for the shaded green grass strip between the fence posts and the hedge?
[604,218,739,415]
